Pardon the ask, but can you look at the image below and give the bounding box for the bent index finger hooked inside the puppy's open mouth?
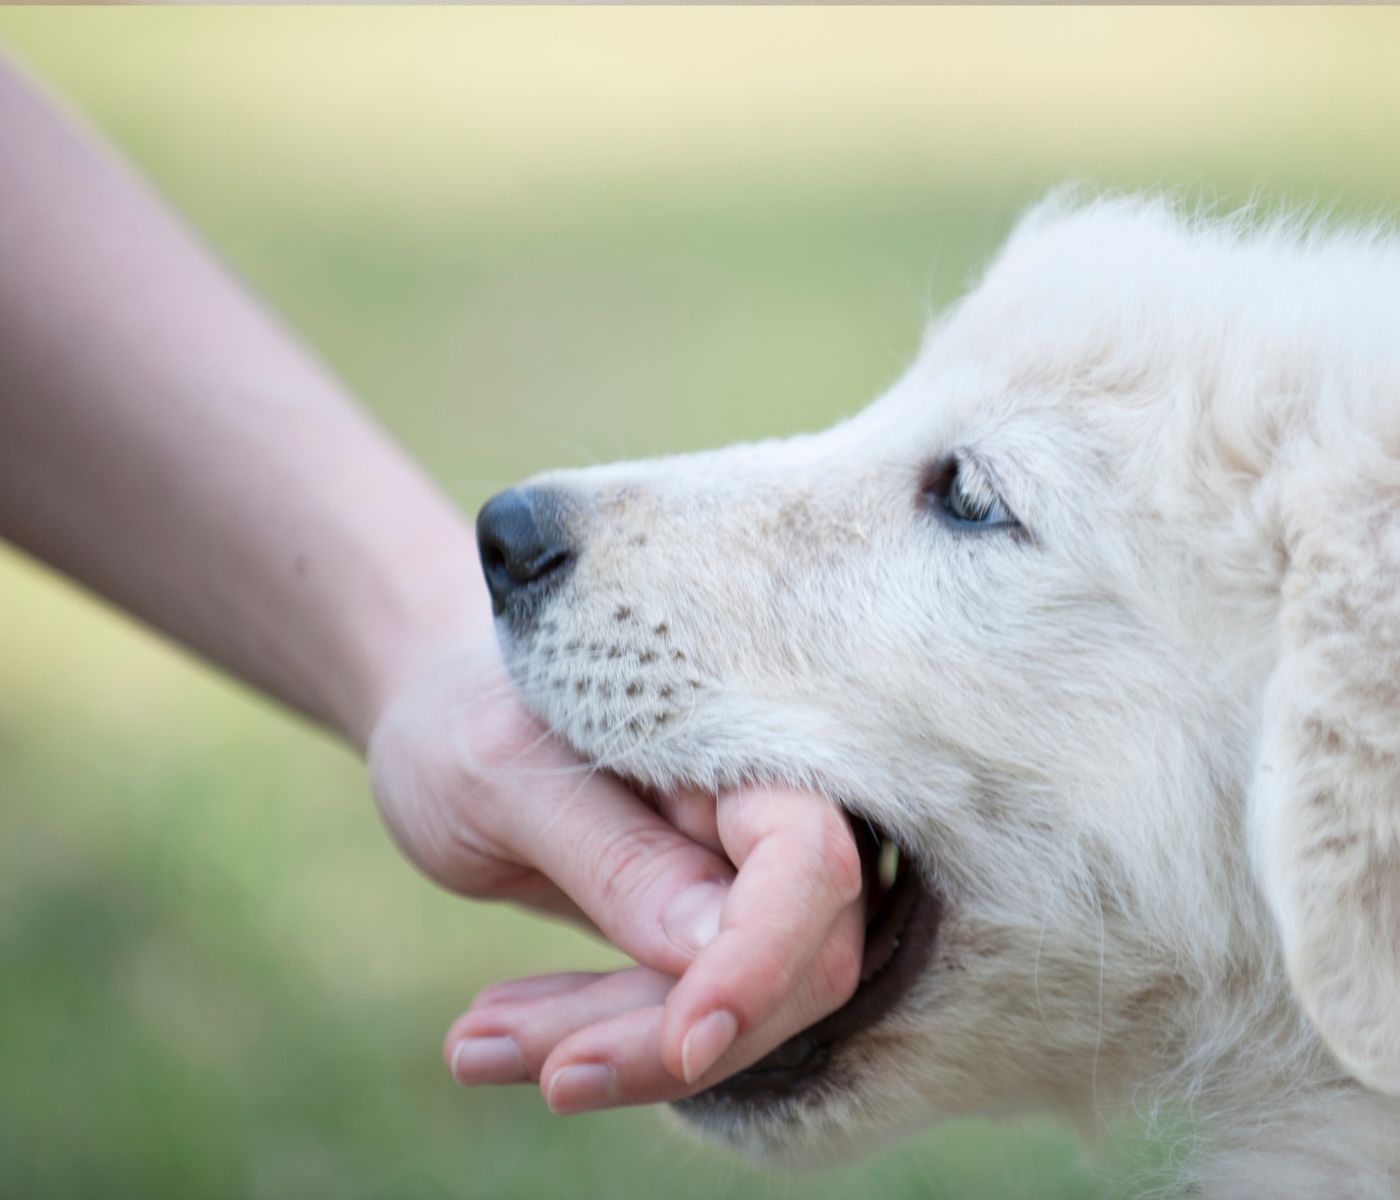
[661,790,864,1081]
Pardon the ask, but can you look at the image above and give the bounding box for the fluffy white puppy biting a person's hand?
[482,197,1400,1200]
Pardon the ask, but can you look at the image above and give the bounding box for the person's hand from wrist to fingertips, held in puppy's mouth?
[370,634,864,1112]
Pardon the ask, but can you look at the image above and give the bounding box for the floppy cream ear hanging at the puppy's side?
[1249,490,1400,1096]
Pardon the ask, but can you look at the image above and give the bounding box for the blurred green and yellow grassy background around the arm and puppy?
[0,8,1400,1200]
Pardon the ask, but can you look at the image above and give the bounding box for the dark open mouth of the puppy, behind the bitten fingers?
[675,816,942,1122]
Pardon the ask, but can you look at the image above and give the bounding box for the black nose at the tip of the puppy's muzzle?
[476,487,573,619]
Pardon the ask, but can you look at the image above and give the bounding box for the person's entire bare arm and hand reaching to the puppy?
[0,63,864,1112]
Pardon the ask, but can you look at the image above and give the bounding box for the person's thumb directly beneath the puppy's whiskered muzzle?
[470,702,734,975]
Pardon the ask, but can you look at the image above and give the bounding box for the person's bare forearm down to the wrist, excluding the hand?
[0,64,487,745]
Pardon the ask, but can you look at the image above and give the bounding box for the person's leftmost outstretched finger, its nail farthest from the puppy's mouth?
[442,968,675,1085]
